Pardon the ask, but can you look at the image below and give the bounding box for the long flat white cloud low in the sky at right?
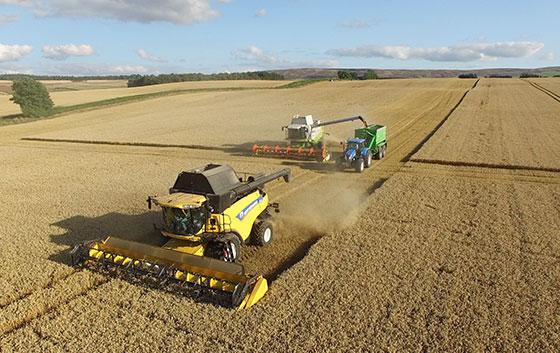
[327,42,544,62]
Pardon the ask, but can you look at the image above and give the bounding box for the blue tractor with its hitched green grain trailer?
[336,125,387,173]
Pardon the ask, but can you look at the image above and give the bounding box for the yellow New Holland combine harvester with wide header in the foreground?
[71,164,291,308]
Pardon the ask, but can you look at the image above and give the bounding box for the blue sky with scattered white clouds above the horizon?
[0,0,560,75]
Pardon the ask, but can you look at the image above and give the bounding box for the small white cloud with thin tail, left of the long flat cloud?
[232,45,339,71]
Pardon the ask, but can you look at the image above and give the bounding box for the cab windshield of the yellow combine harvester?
[163,207,206,235]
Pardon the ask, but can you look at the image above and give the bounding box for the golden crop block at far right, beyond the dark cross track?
[412,79,560,168]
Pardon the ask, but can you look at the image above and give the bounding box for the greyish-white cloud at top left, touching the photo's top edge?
[4,0,219,24]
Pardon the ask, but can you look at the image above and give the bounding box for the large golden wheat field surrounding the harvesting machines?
[0,79,560,352]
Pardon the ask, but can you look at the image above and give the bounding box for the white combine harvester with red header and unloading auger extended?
[253,115,368,162]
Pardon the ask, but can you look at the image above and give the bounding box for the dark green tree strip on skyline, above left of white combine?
[128,71,284,87]
